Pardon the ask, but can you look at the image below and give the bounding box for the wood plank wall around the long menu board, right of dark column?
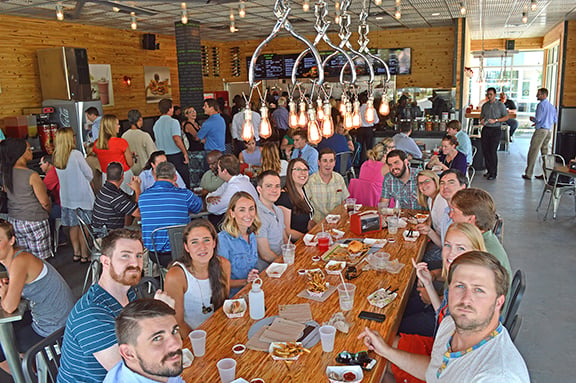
[202,27,454,92]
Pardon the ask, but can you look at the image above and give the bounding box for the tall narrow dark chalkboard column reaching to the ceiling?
[175,20,204,111]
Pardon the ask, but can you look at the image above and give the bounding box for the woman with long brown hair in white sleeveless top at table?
[164,219,230,337]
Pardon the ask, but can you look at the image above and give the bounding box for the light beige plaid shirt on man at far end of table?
[304,172,350,222]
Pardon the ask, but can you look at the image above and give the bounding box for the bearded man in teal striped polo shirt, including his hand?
[58,229,174,383]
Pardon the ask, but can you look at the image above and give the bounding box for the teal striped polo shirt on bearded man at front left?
[57,284,136,383]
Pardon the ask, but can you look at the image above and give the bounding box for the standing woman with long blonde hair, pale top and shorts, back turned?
[52,128,94,263]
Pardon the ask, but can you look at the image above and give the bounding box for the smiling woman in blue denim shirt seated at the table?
[218,191,260,297]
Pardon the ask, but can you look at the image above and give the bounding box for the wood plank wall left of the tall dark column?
[0,15,180,119]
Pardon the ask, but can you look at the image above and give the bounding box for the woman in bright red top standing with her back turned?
[94,114,134,195]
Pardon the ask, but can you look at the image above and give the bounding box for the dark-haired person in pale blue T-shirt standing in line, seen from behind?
[153,98,190,188]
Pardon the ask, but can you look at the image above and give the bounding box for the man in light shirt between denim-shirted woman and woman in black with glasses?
[256,170,288,270]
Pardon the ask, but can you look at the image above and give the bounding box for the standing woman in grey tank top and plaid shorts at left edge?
[0,138,52,259]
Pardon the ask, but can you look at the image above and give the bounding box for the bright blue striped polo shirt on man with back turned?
[138,181,202,253]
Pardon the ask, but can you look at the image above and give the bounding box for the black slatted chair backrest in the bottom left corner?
[22,327,65,383]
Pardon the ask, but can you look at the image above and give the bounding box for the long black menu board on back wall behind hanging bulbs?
[246,48,411,80]
